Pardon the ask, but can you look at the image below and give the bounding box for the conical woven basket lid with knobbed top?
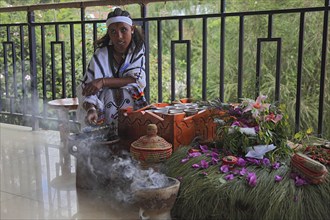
[132,124,172,148]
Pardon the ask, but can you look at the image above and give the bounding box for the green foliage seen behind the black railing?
[0,0,330,139]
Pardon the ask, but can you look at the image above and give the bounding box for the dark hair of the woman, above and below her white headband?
[94,8,144,51]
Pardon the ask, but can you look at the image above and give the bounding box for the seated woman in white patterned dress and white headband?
[78,8,147,132]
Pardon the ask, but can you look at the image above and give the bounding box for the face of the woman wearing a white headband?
[108,22,134,53]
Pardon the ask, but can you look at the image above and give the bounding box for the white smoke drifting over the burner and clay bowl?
[69,138,169,204]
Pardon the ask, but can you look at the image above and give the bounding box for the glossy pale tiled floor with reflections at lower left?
[0,123,139,220]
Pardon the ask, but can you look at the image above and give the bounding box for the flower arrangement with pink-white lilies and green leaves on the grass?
[209,95,292,160]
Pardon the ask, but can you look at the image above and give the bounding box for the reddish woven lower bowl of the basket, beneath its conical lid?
[130,145,172,163]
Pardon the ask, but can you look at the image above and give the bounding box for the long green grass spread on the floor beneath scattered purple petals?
[166,147,330,220]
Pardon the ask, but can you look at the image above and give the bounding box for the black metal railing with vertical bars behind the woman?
[0,0,330,138]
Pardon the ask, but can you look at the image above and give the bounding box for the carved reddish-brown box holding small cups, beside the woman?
[118,104,216,151]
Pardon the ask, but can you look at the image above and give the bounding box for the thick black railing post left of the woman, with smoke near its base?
[27,11,39,130]
